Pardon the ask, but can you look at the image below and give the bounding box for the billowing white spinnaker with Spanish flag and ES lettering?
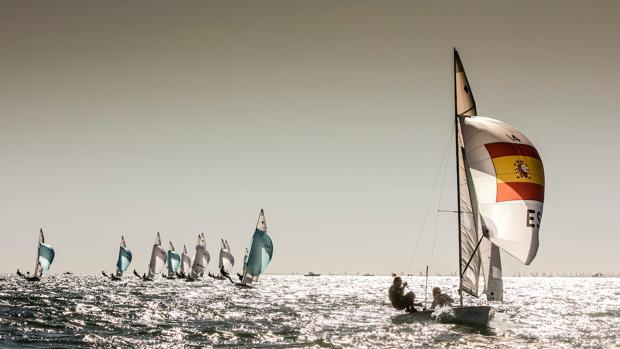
[462,117,545,265]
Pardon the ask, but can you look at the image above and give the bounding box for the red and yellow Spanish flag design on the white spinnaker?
[485,142,545,202]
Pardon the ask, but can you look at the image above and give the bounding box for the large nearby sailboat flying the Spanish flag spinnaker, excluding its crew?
[402,49,545,325]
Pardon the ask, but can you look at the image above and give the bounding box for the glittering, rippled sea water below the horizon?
[0,275,620,348]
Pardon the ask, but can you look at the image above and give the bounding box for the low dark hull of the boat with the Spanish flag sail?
[393,306,495,327]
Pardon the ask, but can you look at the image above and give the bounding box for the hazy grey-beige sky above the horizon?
[0,0,620,275]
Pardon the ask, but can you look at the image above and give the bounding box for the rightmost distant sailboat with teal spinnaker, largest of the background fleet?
[236,209,273,287]
